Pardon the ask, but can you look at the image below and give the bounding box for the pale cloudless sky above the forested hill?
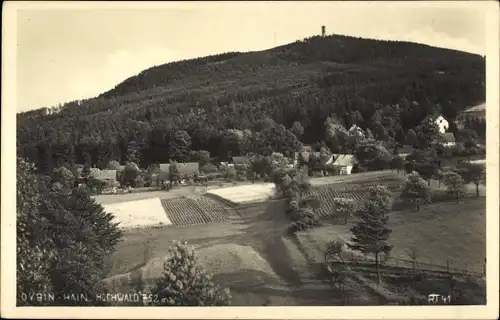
[16,1,486,112]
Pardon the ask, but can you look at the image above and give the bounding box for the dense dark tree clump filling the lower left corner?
[17,159,121,305]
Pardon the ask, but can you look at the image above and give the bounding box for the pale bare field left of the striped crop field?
[103,198,172,229]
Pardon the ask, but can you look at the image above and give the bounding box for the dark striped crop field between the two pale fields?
[161,196,230,226]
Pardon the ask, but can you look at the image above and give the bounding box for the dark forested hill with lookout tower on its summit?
[17,35,485,171]
